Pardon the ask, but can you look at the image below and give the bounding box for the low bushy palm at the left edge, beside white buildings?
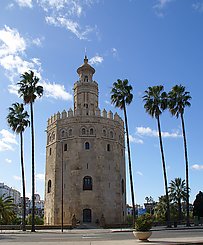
[0,194,15,224]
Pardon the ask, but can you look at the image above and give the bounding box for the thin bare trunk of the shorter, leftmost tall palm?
[20,132,26,231]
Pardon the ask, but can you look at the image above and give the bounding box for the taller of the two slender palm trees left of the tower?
[18,71,43,232]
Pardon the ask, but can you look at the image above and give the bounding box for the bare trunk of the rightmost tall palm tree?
[180,114,190,226]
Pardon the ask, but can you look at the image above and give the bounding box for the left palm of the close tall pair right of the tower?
[143,85,170,226]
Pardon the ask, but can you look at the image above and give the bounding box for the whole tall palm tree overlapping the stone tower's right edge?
[111,79,135,223]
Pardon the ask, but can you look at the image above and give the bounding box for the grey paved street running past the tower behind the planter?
[0,229,203,245]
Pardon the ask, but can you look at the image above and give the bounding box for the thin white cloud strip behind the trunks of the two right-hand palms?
[136,127,182,138]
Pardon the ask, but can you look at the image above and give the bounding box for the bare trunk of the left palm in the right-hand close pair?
[157,116,171,227]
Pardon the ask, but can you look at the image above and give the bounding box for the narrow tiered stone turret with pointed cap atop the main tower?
[74,55,98,115]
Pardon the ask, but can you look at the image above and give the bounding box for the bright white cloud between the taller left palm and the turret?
[41,81,73,101]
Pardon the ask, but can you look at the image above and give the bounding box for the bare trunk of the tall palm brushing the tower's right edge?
[123,102,136,225]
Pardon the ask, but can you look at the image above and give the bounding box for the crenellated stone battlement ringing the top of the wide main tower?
[47,108,123,126]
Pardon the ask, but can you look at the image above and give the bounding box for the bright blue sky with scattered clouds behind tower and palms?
[0,0,203,204]
